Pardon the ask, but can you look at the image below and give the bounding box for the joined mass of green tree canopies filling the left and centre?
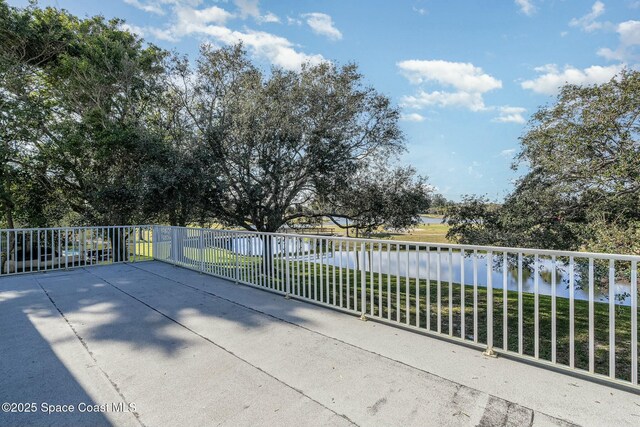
[0,0,429,231]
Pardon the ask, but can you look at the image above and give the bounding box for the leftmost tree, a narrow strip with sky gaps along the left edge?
[0,1,74,228]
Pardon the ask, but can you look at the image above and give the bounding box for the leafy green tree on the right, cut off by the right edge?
[448,70,640,253]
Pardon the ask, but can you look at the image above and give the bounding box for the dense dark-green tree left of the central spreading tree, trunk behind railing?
[0,2,172,259]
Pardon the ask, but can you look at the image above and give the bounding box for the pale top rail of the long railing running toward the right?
[156,226,640,262]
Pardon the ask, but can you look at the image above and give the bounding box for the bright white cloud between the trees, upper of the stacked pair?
[397,59,502,93]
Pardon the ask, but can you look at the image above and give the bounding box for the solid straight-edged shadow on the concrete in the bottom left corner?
[0,279,111,426]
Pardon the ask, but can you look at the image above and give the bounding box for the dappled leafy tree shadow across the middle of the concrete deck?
[21,262,321,356]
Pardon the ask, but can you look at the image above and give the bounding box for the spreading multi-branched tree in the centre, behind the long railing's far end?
[178,46,410,231]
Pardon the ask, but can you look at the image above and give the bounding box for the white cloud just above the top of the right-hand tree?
[521,64,624,95]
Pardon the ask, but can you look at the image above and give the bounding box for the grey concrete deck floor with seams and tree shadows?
[0,262,640,426]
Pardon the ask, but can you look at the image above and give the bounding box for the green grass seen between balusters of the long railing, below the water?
[228,259,640,381]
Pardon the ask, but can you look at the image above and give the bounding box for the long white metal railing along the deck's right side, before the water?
[152,226,640,386]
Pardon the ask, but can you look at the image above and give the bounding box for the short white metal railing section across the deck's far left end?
[0,225,153,276]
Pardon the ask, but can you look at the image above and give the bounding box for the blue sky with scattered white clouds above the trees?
[9,0,640,200]
